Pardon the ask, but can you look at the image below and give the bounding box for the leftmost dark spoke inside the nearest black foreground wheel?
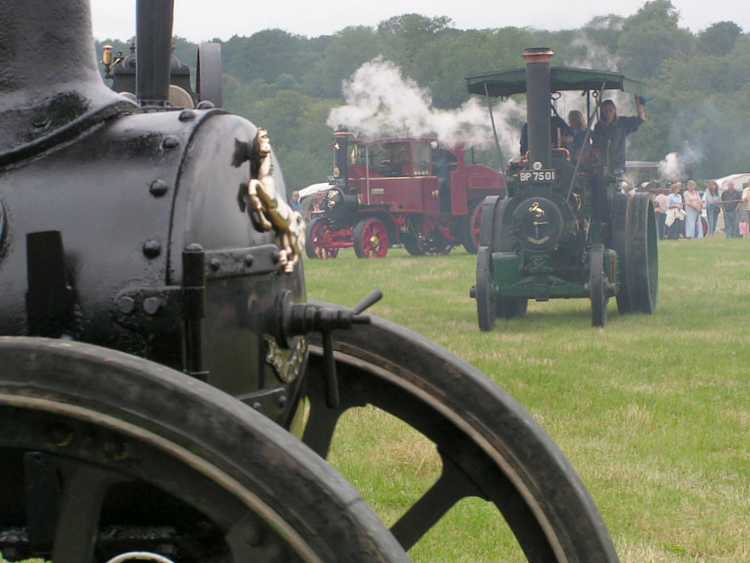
[52,465,120,563]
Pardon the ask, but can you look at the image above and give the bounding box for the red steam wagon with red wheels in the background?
[306,131,505,258]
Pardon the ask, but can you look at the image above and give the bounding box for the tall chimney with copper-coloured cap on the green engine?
[523,47,555,168]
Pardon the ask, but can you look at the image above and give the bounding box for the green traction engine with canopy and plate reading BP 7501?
[467,48,658,331]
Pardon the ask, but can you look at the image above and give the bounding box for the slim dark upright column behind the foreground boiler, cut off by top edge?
[135,0,174,106]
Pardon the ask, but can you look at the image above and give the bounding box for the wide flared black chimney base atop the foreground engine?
[0,0,132,165]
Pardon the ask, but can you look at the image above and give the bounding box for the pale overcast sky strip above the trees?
[91,0,750,41]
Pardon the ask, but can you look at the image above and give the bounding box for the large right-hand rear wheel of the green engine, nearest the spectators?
[625,194,659,314]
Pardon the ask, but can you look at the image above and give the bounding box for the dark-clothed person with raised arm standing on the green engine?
[592,96,646,175]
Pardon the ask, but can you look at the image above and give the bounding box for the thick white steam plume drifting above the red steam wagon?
[327,57,526,158]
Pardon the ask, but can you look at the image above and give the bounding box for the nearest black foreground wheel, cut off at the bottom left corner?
[0,337,406,563]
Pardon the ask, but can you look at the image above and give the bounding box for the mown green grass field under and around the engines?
[305,239,750,563]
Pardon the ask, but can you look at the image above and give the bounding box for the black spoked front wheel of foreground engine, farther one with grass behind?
[304,320,617,563]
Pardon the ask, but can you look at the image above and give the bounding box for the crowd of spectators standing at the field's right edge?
[652,180,750,239]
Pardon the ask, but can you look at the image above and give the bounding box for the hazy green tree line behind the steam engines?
[95,0,750,188]
